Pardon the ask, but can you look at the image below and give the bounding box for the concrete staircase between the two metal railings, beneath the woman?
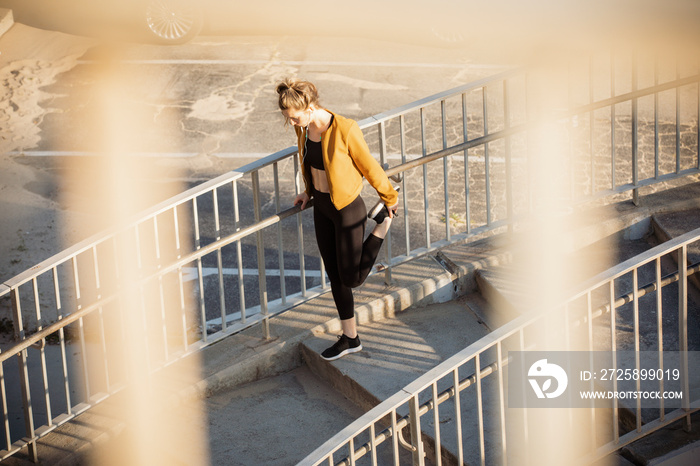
[6,184,700,465]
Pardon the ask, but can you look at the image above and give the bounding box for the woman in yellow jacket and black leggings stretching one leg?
[277,78,398,361]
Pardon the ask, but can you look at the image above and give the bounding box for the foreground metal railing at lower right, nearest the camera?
[299,229,700,466]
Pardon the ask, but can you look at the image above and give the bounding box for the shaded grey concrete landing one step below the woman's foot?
[206,366,363,466]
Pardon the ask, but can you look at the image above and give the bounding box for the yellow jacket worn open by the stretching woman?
[294,112,399,210]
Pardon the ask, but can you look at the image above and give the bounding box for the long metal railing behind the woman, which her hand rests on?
[0,52,700,459]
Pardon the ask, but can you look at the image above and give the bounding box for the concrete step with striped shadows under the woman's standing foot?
[302,301,490,459]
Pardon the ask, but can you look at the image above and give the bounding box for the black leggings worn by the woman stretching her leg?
[314,190,384,320]
